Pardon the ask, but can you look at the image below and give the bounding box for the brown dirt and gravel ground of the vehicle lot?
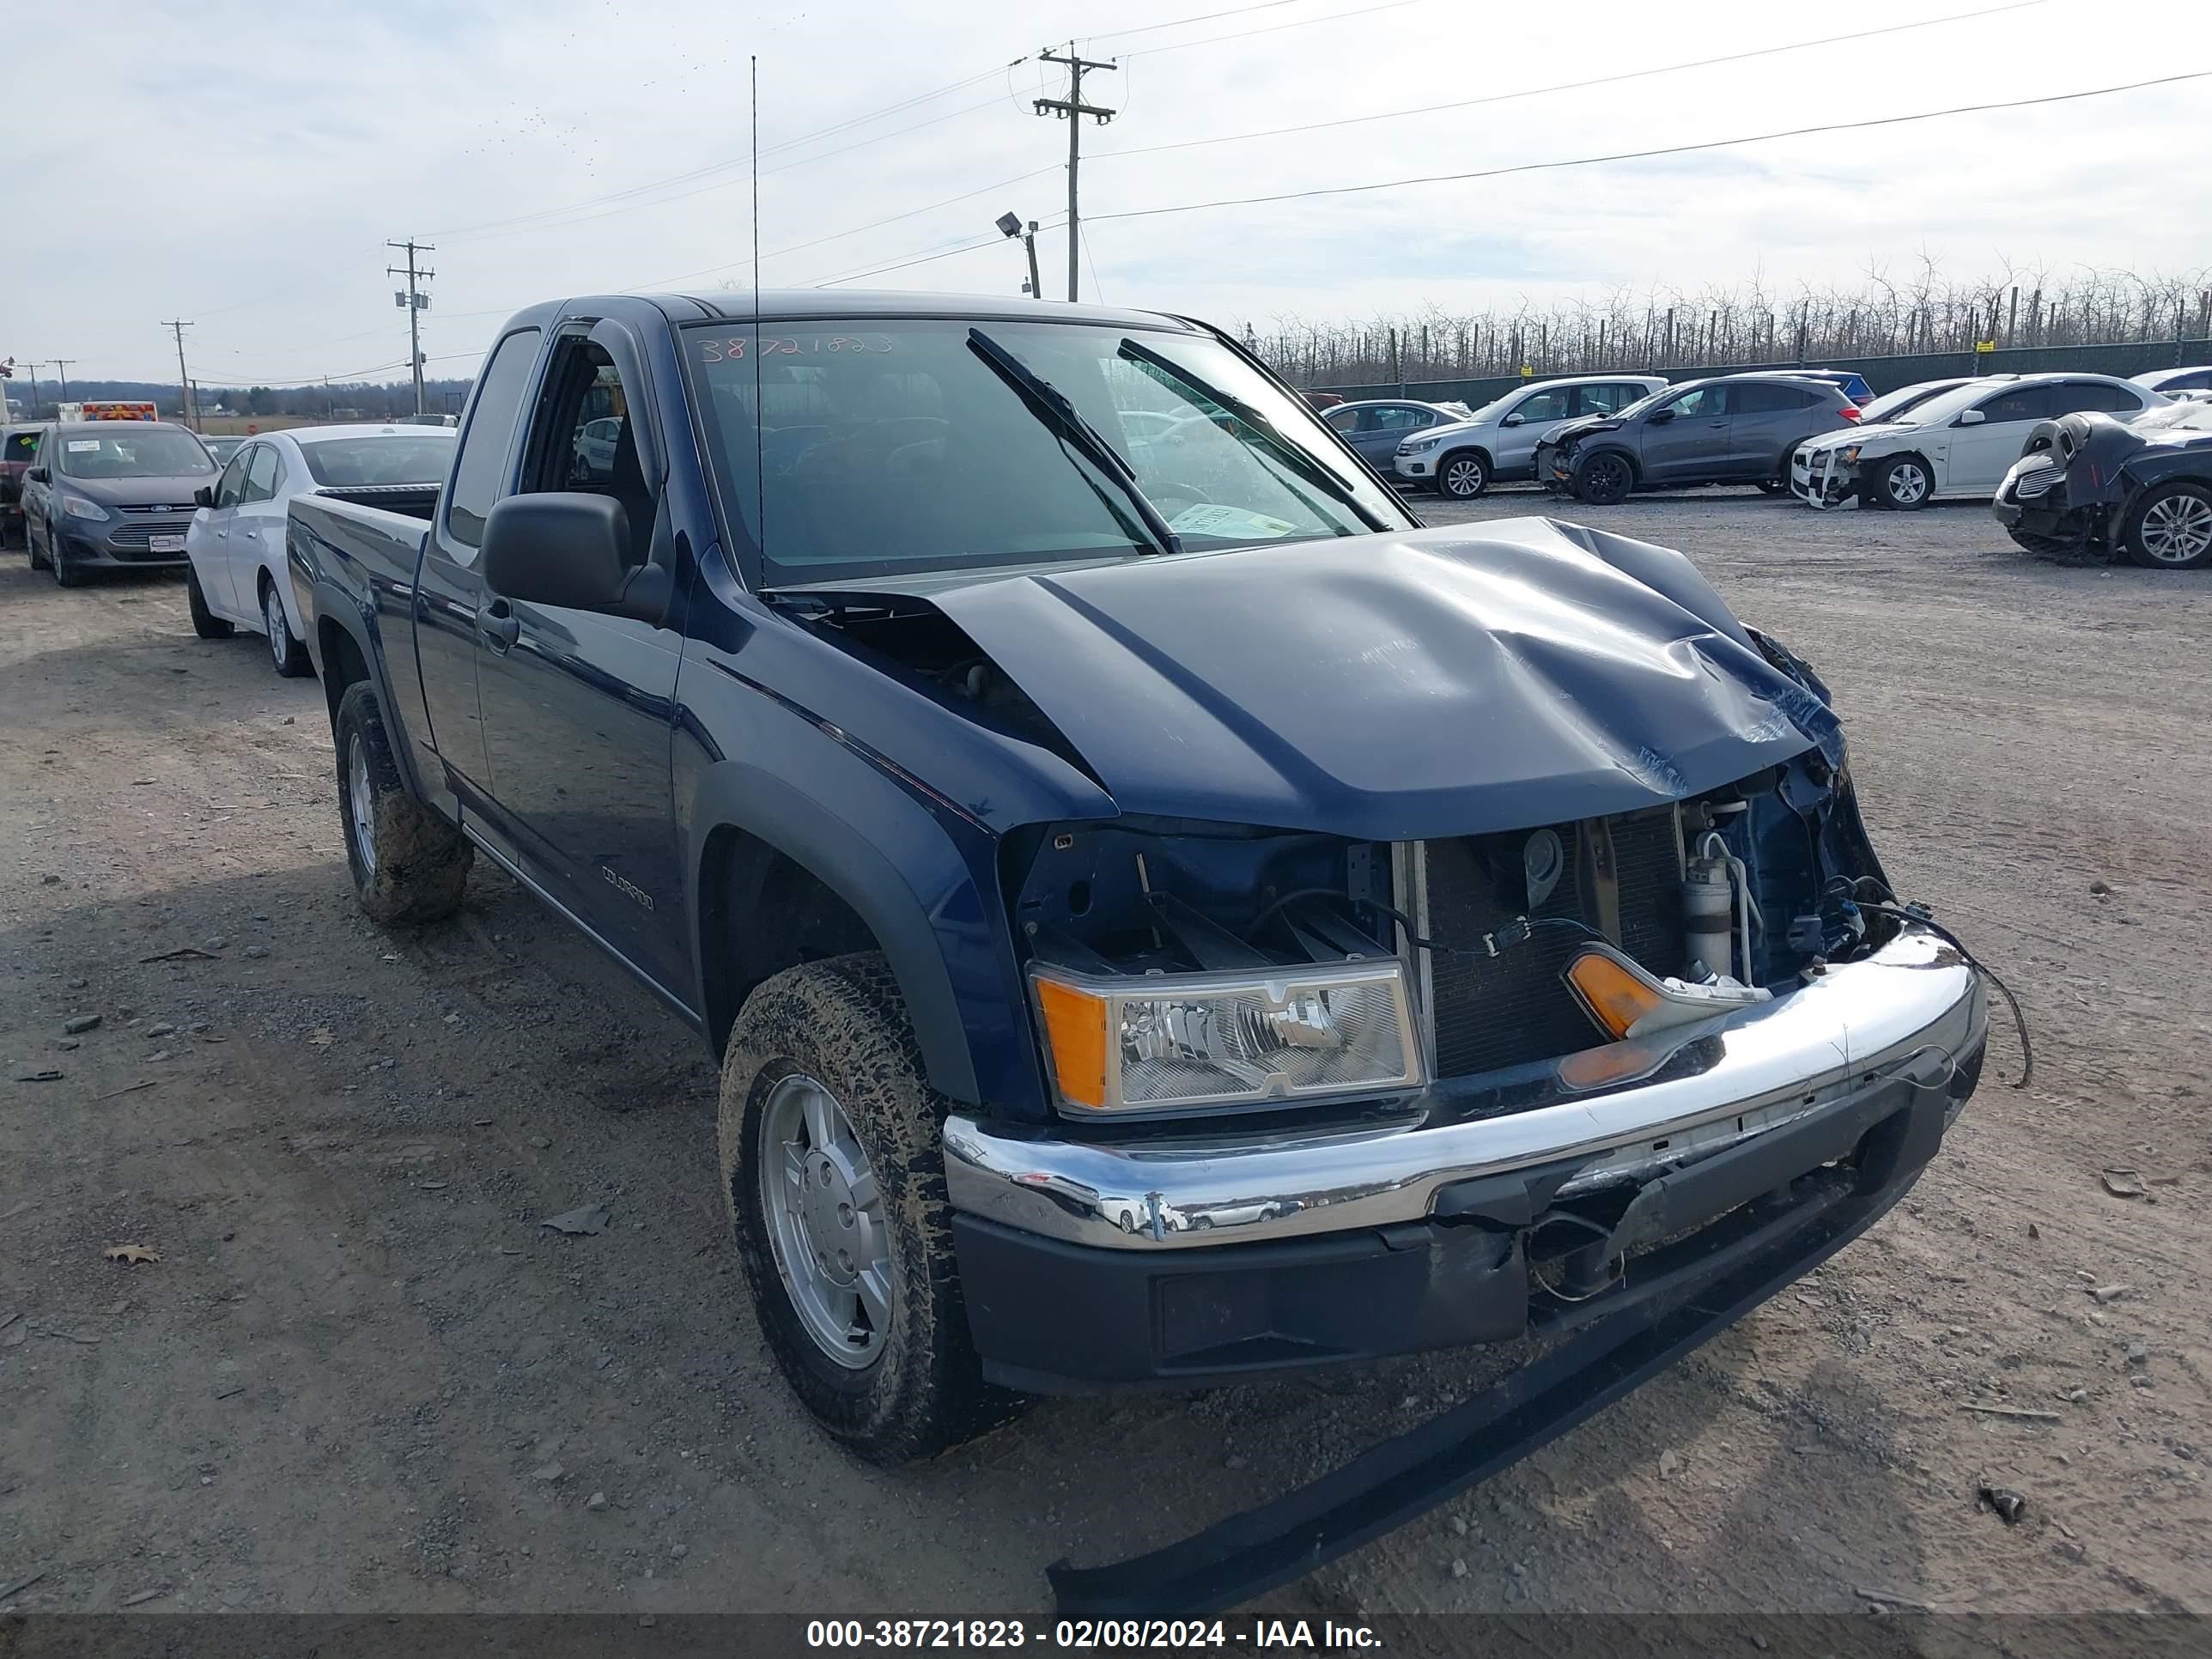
[0,493,2212,1614]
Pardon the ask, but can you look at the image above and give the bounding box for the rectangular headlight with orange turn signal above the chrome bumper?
[1030,957,1422,1117]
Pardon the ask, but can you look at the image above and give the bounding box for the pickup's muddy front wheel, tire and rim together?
[719,951,1020,1464]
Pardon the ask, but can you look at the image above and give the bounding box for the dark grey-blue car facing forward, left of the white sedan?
[22,420,215,588]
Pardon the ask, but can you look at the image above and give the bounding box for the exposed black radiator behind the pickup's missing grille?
[1422,807,1686,1078]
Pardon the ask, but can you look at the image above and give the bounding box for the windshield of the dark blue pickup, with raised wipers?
[686,319,1411,586]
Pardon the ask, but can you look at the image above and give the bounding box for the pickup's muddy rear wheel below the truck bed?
[331,679,476,927]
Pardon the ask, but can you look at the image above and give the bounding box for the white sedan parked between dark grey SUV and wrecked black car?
[1790,374,2167,511]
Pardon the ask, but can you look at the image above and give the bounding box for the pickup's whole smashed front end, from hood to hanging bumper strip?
[774,522,1986,1613]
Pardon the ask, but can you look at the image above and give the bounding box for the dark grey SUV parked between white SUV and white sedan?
[1537,374,1858,504]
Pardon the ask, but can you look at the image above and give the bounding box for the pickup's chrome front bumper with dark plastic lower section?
[945,925,1986,1391]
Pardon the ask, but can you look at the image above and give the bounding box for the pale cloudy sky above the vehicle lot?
[0,0,2212,383]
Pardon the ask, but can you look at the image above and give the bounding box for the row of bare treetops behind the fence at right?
[1248,261,2212,385]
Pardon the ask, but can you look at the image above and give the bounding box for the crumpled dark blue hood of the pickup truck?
[907,518,1843,841]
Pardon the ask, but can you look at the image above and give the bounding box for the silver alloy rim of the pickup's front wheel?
[759,1073,891,1371]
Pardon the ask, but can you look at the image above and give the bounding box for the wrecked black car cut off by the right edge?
[1990,403,2212,571]
